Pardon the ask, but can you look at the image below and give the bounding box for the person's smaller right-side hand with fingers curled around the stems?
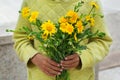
[61,54,81,69]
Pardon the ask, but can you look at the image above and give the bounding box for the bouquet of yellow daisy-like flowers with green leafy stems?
[7,1,105,80]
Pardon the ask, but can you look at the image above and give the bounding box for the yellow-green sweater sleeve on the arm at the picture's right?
[78,0,112,69]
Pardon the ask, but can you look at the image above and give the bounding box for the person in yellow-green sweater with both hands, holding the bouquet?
[13,0,112,80]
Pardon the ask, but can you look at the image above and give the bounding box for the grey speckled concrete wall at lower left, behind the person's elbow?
[0,36,26,80]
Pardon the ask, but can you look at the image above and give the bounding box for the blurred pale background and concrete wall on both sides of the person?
[0,0,120,80]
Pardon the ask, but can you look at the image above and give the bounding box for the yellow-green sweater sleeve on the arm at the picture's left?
[13,0,38,64]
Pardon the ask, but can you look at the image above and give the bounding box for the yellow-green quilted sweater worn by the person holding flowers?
[13,0,112,80]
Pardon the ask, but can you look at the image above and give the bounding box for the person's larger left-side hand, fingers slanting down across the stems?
[31,54,62,76]
